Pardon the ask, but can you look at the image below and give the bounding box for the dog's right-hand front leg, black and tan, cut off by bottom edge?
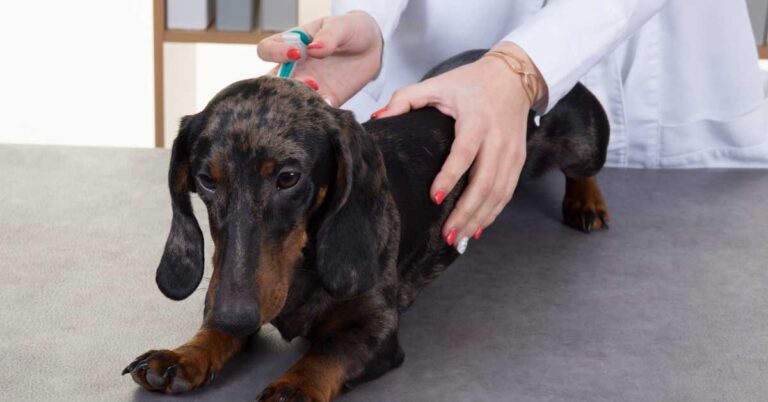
[256,303,403,402]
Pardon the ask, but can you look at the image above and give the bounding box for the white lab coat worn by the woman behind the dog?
[333,0,768,168]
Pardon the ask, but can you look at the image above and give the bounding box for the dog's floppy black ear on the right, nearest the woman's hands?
[316,110,384,298]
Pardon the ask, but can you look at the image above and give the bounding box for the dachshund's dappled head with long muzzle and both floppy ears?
[156,77,386,334]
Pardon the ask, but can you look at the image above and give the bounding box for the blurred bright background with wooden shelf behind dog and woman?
[0,0,768,147]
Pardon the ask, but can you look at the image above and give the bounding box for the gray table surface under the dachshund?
[0,145,768,402]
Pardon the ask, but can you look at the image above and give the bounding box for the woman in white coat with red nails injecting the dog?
[258,0,768,251]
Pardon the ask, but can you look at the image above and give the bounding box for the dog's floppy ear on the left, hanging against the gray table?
[155,116,204,300]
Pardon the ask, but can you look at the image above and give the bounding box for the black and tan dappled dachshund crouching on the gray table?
[123,51,608,402]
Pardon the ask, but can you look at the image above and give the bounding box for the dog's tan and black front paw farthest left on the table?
[123,350,215,394]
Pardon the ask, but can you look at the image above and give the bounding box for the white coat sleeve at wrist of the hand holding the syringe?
[331,0,408,100]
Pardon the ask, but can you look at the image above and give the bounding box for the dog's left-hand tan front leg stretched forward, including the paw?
[123,325,245,394]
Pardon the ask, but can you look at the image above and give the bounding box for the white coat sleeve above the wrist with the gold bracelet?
[510,0,668,113]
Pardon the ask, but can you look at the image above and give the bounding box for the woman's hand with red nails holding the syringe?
[257,11,383,106]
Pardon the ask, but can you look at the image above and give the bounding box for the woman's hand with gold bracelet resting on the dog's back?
[371,42,544,253]
